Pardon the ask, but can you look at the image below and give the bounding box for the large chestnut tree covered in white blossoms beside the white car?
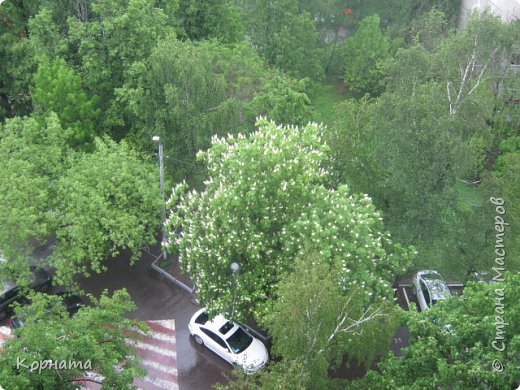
[167,118,411,319]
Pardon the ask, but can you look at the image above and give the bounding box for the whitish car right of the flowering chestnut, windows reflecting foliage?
[413,271,451,310]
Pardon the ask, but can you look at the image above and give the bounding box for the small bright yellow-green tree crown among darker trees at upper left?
[32,59,99,146]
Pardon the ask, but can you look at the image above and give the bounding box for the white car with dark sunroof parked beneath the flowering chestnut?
[188,309,269,374]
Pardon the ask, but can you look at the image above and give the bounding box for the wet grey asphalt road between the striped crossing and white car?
[76,250,231,390]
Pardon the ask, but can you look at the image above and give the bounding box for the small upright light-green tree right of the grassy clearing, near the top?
[342,15,392,95]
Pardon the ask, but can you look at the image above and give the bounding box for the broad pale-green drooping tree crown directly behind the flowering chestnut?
[118,40,310,183]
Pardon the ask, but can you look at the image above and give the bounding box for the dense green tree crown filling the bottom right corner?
[353,274,520,390]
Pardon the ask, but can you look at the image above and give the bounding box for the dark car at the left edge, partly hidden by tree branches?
[0,266,52,320]
